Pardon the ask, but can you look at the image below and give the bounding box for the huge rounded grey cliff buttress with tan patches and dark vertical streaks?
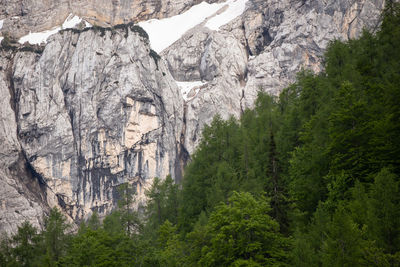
[0,25,183,232]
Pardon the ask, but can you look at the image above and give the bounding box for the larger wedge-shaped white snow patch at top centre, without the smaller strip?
[139,2,226,53]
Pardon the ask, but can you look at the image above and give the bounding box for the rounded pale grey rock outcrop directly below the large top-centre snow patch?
[163,27,248,153]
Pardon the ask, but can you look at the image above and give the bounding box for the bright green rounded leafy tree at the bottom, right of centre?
[200,192,287,266]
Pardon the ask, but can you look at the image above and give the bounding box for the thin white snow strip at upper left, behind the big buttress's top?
[18,14,91,44]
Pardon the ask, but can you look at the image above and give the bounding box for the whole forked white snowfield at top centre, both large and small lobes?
[139,0,248,53]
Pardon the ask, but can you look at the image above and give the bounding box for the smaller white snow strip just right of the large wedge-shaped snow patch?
[206,0,248,31]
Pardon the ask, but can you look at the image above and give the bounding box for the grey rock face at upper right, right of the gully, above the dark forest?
[239,0,384,99]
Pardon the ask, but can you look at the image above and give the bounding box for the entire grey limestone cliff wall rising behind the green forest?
[0,0,384,232]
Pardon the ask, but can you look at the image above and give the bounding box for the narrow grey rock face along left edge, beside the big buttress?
[0,53,45,232]
